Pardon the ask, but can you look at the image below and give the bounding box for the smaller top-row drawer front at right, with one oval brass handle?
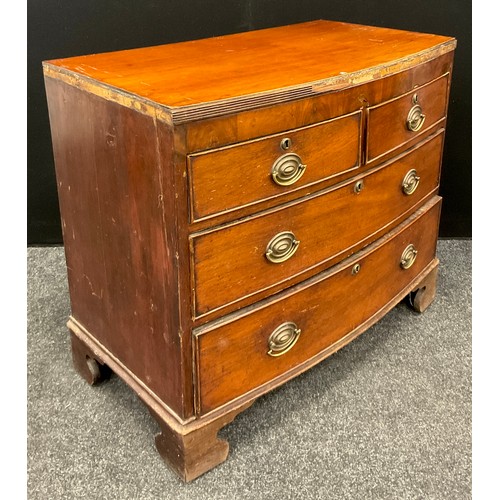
[367,75,448,162]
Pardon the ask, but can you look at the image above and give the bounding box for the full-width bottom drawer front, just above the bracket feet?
[195,197,441,413]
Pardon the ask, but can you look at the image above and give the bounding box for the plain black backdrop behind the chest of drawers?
[27,0,472,245]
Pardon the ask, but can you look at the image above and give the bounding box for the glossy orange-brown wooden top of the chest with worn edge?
[44,20,456,114]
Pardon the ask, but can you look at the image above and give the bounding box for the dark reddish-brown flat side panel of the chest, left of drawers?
[46,78,183,416]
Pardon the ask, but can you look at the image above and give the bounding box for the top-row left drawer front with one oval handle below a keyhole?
[188,111,361,221]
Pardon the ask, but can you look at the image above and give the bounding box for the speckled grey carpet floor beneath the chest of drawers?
[27,240,472,500]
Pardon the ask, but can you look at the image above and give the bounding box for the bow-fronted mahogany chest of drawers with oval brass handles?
[43,21,456,480]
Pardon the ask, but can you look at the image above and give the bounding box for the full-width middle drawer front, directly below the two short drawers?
[191,132,443,316]
